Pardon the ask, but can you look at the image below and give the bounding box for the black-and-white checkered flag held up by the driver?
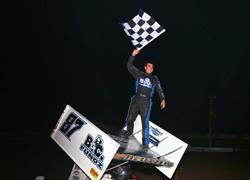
[121,9,166,49]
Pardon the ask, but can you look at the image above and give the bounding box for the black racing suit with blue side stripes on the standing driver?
[126,55,165,145]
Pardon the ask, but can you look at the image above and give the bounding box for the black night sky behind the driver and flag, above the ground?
[0,0,250,179]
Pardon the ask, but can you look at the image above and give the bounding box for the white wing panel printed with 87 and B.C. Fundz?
[51,105,119,180]
